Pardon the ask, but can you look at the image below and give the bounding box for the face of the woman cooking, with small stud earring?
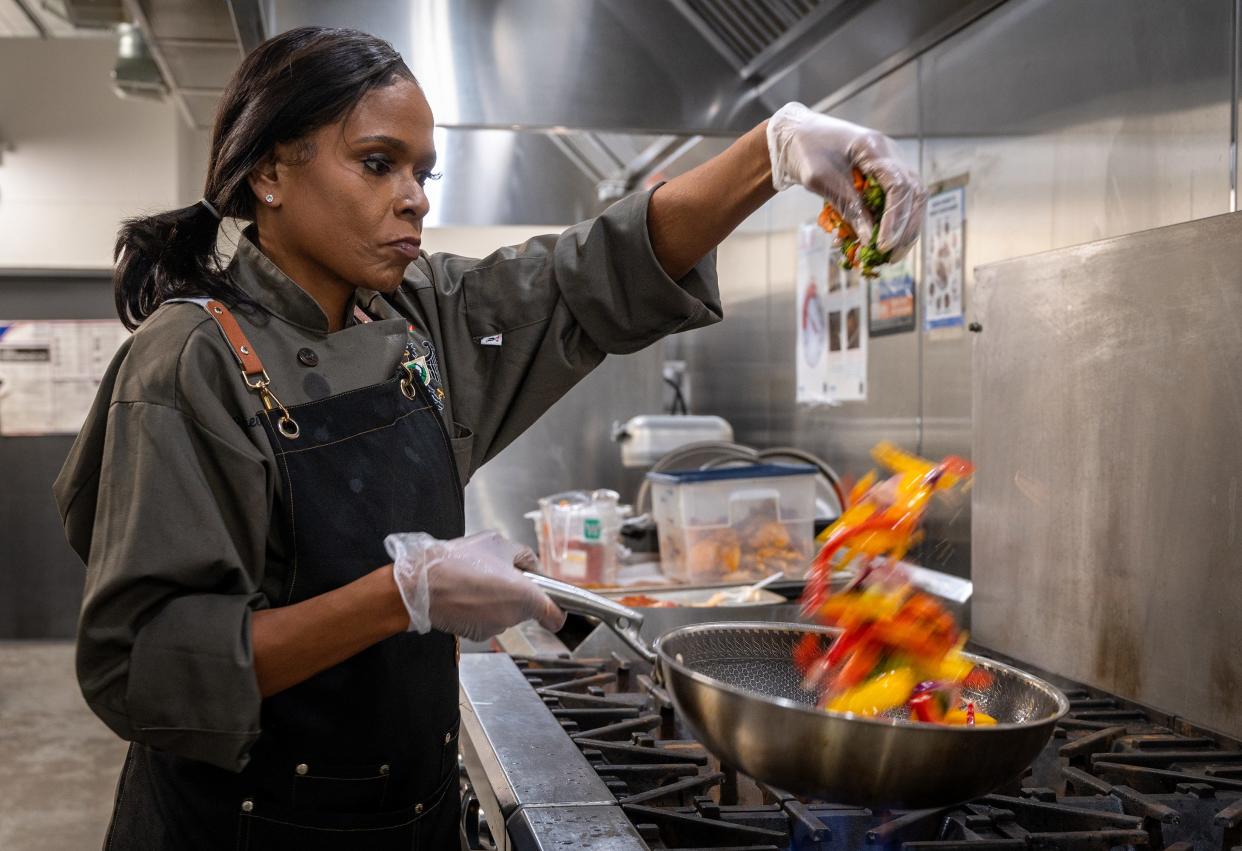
[252,78,436,293]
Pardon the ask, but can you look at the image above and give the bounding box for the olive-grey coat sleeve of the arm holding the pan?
[57,318,268,770]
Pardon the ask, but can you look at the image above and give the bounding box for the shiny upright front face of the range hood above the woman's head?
[270,0,769,135]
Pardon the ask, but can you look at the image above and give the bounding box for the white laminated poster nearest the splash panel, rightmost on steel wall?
[923,186,966,330]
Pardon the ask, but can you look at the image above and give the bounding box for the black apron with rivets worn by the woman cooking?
[104,301,465,851]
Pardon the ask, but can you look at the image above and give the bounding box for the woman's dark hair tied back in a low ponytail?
[113,26,414,329]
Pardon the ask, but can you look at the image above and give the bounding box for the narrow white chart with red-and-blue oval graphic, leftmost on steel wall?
[794,225,831,405]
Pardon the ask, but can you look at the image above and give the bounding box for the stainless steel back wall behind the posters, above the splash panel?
[674,0,1235,575]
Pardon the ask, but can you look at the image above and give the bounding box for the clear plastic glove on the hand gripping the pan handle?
[384,532,565,641]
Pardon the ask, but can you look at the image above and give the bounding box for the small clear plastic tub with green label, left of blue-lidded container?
[527,491,630,585]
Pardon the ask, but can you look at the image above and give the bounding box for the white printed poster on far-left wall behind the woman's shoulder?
[0,319,129,437]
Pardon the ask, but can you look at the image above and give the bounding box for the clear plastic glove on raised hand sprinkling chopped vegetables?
[768,103,927,260]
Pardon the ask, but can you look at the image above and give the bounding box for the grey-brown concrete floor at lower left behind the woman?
[0,641,125,851]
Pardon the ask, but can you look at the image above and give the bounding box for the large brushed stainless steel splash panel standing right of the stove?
[972,214,1242,735]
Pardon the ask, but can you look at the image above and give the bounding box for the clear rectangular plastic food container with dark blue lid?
[647,465,816,584]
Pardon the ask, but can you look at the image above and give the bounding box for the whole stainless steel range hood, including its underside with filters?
[111,0,1002,225]
